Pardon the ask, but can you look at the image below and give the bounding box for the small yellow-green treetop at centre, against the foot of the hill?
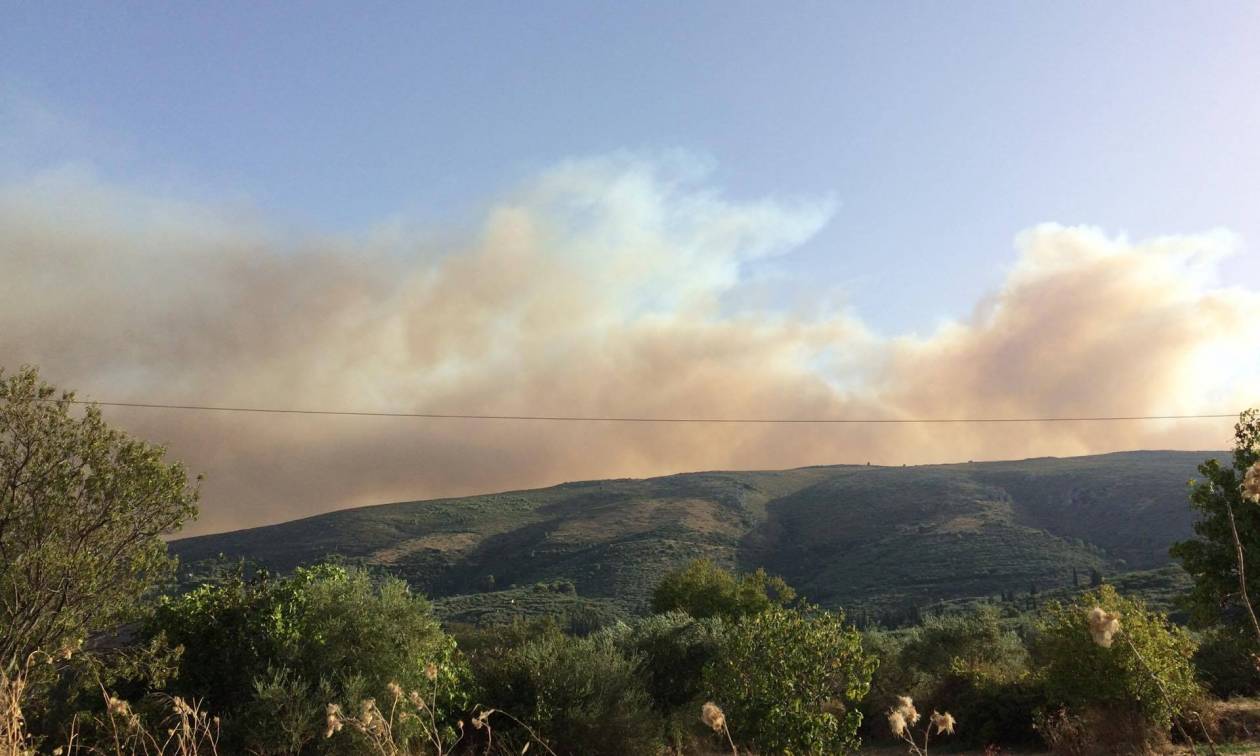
[651,559,796,620]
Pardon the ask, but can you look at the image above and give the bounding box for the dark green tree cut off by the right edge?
[1171,410,1260,636]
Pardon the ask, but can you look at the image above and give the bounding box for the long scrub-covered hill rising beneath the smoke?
[170,451,1209,624]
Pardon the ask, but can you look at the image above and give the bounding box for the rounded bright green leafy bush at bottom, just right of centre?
[704,607,876,753]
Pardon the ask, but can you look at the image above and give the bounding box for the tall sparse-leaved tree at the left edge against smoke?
[0,367,197,665]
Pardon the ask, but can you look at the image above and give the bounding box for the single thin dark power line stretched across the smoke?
[49,399,1239,425]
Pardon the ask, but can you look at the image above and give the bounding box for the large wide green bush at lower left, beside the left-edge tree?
[151,564,471,753]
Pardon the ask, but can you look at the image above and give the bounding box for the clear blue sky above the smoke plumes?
[0,1,1260,333]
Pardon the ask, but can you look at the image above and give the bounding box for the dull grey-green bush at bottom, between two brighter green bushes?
[475,630,662,756]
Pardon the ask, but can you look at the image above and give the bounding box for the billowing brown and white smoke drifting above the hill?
[0,156,1260,532]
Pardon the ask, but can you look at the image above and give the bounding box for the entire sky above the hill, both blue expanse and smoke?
[0,3,1260,532]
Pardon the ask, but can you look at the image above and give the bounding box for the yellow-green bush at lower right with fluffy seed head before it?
[1032,585,1202,732]
